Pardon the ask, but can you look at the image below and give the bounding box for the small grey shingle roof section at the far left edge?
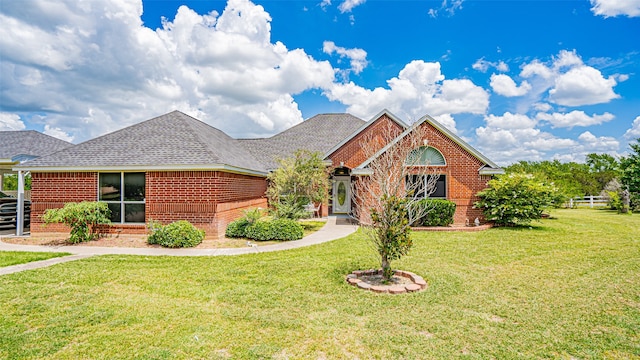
[0,130,72,159]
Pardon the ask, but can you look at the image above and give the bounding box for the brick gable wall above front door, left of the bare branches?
[329,115,404,169]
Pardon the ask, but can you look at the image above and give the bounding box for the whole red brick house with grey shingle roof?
[16,111,502,236]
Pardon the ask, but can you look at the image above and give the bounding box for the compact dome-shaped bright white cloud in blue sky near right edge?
[549,66,620,106]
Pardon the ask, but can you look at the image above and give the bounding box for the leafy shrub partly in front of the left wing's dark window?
[42,201,111,244]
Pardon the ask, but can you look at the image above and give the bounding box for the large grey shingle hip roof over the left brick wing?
[18,111,266,173]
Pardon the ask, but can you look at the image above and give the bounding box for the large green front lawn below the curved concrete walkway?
[0,210,640,359]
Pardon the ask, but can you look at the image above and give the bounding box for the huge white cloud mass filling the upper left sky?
[0,0,335,141]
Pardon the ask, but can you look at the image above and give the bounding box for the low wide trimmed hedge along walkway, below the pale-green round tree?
[225,219,304,241]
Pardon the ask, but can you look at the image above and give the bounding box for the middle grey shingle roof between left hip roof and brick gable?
[240,114,365,169]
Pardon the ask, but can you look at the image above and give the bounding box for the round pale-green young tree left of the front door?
[267,150,329,218]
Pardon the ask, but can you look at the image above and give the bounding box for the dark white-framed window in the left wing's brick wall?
[98,173,145,223]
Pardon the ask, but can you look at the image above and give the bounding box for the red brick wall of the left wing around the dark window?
[31,171,267,237]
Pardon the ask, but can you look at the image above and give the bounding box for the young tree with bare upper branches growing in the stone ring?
[351,120,438,280]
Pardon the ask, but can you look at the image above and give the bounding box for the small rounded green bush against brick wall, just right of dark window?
[147,220,204,248]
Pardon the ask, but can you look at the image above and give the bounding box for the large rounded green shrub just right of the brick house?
[475,173,555,226]
